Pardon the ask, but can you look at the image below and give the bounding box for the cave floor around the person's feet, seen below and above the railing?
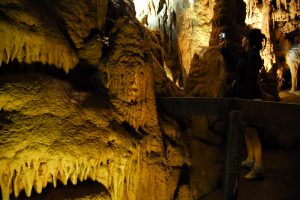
[237,91,300,200]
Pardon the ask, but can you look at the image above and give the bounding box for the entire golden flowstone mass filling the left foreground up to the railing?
[0,0,222,200]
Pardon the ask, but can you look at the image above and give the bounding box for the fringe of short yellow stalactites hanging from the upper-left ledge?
[0,22,78,73]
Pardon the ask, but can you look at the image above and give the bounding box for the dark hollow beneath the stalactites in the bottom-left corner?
[0,179,111,200]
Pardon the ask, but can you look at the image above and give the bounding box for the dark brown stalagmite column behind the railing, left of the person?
[185,1,245,97]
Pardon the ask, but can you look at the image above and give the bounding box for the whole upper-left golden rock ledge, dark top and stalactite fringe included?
[0,1,78,72]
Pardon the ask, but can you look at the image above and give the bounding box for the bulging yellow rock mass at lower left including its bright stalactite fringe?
[0,74,147,200]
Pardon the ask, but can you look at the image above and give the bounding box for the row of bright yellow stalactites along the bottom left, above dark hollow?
[0,148,141,200]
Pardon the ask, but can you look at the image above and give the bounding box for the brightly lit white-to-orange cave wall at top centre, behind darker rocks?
[134,0,215,85]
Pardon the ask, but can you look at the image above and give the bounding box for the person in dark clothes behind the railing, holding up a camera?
[219,29,266,180]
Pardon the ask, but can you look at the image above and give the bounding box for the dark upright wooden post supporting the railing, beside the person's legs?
[222,110,244,200]
